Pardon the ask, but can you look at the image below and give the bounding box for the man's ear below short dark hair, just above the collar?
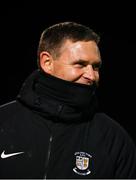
[40,51,53,74]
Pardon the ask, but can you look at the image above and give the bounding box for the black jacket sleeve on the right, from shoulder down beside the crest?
[94,113,136,178]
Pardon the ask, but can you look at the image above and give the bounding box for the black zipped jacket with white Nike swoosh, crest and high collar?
[0,71,136,179]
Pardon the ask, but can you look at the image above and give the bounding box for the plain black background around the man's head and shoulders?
[0,1,136,142]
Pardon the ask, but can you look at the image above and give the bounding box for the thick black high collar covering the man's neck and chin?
[17,70,96,122]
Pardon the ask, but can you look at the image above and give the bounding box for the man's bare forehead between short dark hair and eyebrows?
[61,40,100,59]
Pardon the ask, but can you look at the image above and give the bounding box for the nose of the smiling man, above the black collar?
[84,64,95,81]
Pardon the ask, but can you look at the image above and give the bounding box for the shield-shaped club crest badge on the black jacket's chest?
[73,152,92,176]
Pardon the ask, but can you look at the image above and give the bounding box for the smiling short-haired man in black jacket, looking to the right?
[0,22,136,179]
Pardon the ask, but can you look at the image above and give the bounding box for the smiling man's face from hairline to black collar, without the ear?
[51,40,101,85]
